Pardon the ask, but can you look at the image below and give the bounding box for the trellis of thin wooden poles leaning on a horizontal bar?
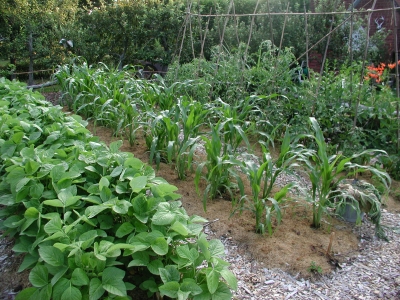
[176,0,400,149]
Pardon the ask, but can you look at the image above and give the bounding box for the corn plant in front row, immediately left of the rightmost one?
[232,131,303,235]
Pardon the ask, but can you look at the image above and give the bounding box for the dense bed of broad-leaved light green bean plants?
[0,79,237,300]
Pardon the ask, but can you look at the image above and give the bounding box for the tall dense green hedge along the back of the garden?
[0,0,387,78]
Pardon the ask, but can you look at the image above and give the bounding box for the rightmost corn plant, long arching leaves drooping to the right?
[299,117,390,234]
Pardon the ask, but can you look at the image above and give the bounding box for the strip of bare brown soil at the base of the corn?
[0,94,400,299]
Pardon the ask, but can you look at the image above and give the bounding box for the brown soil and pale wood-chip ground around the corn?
[0,90,400,299]
